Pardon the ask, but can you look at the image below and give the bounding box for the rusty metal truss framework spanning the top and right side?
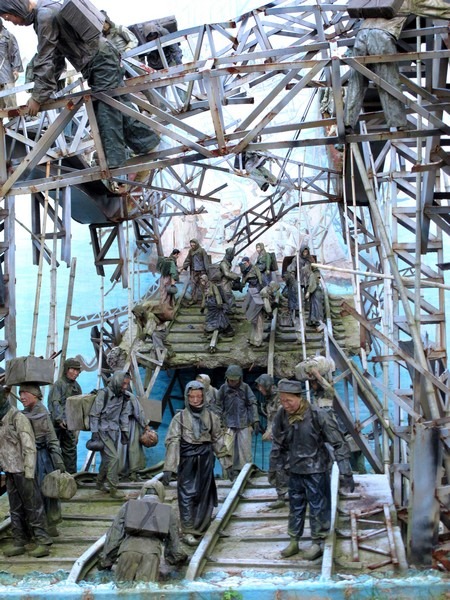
[0,0,450,564]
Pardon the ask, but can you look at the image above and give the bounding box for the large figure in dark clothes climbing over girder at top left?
[0,0,159,168]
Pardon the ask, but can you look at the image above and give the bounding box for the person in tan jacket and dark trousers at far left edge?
[0,387,52,558]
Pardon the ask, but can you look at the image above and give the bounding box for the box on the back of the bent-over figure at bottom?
[125,499,172,536]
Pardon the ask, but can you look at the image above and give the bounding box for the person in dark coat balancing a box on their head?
[19,383,66,537]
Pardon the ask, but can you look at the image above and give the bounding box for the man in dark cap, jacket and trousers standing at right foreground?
[269,379,355,560]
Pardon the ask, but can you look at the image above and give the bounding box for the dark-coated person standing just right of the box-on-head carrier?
[47,358,81,473]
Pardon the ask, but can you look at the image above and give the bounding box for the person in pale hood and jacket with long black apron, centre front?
[162,381,230,546]
